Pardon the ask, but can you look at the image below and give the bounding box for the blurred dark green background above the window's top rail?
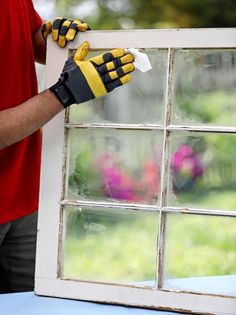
[33,0,236,30]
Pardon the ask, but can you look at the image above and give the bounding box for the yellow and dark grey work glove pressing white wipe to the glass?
[50,42,134,107]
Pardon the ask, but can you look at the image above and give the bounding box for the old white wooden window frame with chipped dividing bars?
[35,28,236,315]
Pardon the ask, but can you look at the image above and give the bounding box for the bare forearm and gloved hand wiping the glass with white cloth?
[0,42,134,149]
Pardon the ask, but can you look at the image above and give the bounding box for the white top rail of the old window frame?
[68,28,236,49]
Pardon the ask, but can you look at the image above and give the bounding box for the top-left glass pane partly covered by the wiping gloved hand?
[70,49,167,124]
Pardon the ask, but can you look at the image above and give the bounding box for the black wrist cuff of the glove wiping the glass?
[49,79,76,108]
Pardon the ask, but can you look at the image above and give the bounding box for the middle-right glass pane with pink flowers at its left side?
[168,132,236,210]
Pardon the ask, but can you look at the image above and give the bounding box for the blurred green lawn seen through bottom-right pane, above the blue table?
[167,216,236,277]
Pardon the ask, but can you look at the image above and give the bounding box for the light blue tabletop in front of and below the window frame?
[0,292,183,315]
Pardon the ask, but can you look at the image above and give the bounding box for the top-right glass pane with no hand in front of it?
[172,50,236,126]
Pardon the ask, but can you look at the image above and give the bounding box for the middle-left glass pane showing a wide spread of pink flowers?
[66,129,162,204]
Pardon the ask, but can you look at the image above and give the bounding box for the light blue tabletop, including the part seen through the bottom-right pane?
[0,275,236,315]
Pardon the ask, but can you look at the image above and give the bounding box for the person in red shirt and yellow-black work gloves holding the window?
[0,0,134,293]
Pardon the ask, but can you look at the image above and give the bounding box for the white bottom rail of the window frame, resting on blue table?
[36,279,236,315]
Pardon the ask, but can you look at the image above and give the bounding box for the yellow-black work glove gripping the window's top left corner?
[41,17,90,48]
